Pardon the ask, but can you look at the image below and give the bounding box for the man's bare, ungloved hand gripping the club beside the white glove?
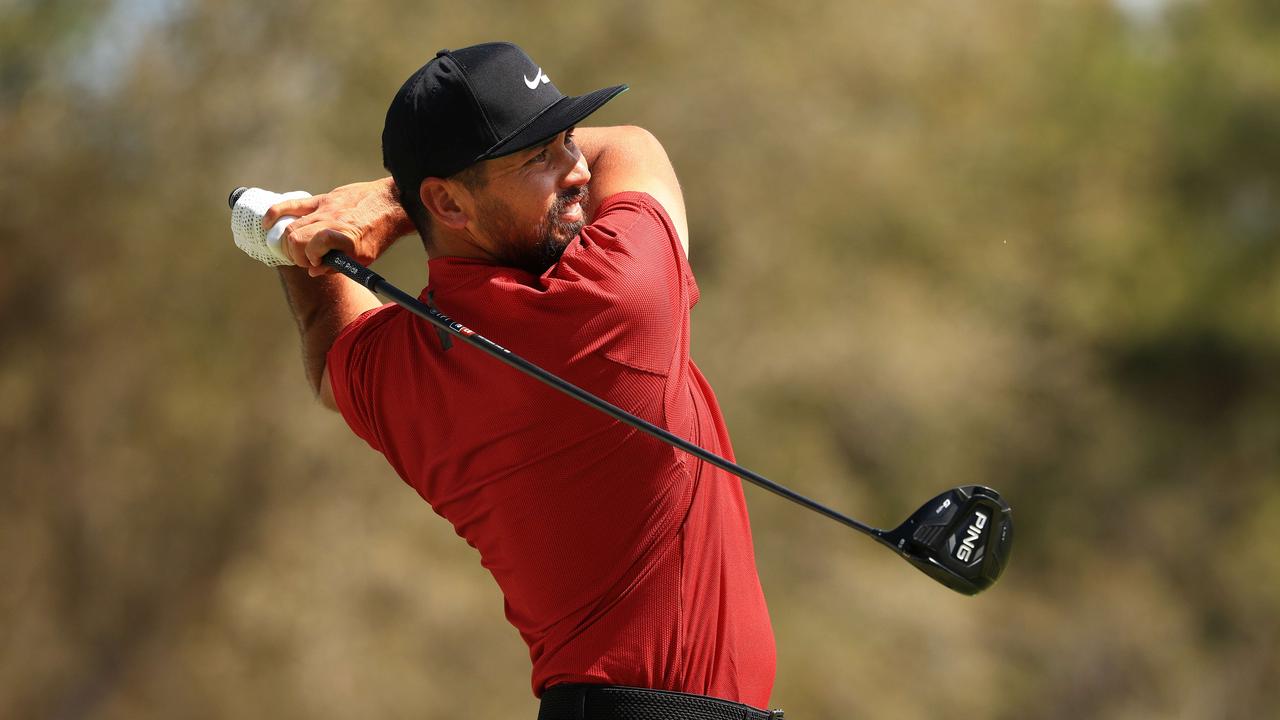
[262,178,413,277]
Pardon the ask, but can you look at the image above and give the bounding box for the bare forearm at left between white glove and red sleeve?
[280,266,381,397]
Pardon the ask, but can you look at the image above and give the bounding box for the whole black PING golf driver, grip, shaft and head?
[228,187,1014,594]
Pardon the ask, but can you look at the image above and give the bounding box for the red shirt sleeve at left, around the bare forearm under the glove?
[325,299,396,452]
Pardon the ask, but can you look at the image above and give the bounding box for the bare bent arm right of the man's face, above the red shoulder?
[573,126,689,256]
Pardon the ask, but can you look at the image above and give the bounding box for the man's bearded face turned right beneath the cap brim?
[471,129,591,275]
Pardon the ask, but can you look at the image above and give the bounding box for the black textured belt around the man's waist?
[538,685,782,720]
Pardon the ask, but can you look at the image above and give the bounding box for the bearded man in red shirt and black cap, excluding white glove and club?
[265,44,774,720]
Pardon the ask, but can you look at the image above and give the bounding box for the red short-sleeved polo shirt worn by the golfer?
[328,192,774,707]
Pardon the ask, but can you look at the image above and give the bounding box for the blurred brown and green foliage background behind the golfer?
[0,0,1280,720]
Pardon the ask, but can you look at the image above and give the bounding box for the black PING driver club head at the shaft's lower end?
[879,486,1014,594]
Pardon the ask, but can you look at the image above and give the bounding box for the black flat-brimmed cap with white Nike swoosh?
[383,42,627,184]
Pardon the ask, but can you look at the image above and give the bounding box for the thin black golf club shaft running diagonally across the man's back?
[324,250,884,542]
